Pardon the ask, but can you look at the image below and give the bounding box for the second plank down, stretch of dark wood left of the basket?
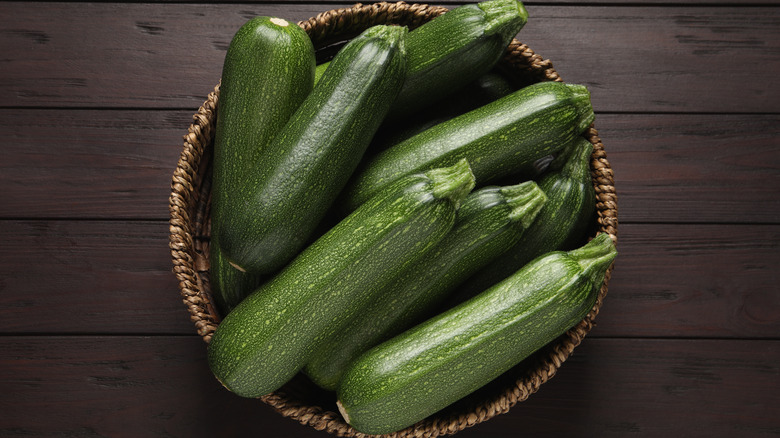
[0,110,190,219]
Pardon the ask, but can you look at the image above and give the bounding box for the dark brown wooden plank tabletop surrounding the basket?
[0,0,780,438]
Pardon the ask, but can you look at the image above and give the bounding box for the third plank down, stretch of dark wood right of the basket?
[592,224,780,339]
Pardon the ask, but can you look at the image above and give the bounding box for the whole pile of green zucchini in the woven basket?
[208,0,616,434]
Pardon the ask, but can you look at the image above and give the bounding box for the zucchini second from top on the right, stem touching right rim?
[341,82,594,211]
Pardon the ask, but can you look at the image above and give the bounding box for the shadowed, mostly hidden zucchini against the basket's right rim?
[459,138,596,297]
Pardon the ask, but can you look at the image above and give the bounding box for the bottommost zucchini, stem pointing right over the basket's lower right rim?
[338,234,617,434]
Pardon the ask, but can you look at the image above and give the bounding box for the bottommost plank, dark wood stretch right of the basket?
[458,339,780,438]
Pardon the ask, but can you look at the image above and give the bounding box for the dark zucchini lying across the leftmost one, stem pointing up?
[215,26,407,274]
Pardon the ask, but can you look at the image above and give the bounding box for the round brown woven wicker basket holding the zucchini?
[170,2,618,438]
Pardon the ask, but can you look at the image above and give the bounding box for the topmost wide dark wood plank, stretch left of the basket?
[0,2,336,108]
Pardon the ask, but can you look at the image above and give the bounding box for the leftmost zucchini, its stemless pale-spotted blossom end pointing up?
[211,17,315,278]
